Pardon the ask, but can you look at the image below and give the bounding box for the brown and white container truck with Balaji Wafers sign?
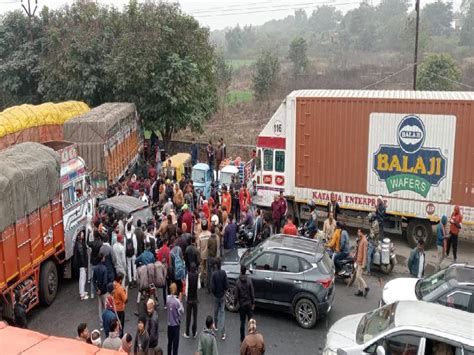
[253,90,474,246]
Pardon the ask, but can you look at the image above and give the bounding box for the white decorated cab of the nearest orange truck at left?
[43,141,93,260]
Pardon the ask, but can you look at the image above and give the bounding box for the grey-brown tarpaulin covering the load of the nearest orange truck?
[0,143,61,232]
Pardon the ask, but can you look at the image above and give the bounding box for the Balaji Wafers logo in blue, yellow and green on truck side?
[372,115,446,197]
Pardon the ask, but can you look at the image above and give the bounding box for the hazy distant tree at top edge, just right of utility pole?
[420,0,453,36]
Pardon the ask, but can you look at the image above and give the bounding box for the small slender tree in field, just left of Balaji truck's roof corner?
[252,51,280,101]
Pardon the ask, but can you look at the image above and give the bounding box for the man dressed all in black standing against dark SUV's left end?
[236,265,255,342]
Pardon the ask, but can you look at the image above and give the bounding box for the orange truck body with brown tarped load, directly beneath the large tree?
[64,103,143,193]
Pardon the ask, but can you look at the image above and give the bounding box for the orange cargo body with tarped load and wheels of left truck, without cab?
[0,143,65,319]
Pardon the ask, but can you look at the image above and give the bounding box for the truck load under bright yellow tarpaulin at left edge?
[0,101,90,150]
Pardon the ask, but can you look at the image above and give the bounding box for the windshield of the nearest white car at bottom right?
[356,303,397,344]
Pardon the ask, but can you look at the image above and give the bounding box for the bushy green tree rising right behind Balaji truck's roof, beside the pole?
[417,54,461,91]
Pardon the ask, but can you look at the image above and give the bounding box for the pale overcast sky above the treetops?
[0,0,461,30]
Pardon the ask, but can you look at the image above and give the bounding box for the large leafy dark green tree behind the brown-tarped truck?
[106,1,217,149]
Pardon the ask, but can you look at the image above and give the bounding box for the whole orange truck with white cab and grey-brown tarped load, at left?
[0,141,92,320]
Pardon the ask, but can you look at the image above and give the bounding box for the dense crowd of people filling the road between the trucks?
[67,153,271,354]
